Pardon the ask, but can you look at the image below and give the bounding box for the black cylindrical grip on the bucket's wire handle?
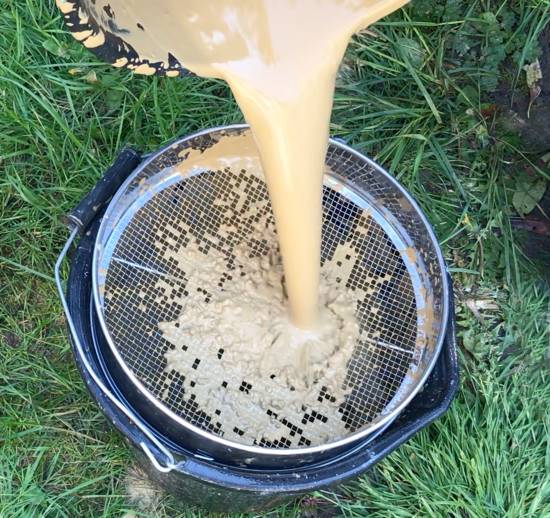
[63,148,141,234]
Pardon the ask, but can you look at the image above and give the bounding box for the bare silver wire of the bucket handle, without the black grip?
[54,230,178,473]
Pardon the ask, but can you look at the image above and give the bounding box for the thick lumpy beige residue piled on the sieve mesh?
[159,207,359,446]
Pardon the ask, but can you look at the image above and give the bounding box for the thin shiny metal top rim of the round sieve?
[92,124,449,457]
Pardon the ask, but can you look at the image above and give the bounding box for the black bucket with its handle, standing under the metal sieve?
[56,151,458,512]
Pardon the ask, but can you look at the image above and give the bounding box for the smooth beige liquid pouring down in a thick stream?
[66,0,408,329]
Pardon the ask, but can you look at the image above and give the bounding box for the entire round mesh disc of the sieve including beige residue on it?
[105,157,416,448]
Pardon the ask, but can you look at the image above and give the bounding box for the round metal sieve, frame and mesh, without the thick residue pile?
[87,126,448,468]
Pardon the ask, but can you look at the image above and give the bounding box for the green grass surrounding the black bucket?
[0,0,550,518]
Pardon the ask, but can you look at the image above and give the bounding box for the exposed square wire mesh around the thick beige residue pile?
[95,128,448,448]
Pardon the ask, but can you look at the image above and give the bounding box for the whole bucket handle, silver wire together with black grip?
[54,150,177,473]
